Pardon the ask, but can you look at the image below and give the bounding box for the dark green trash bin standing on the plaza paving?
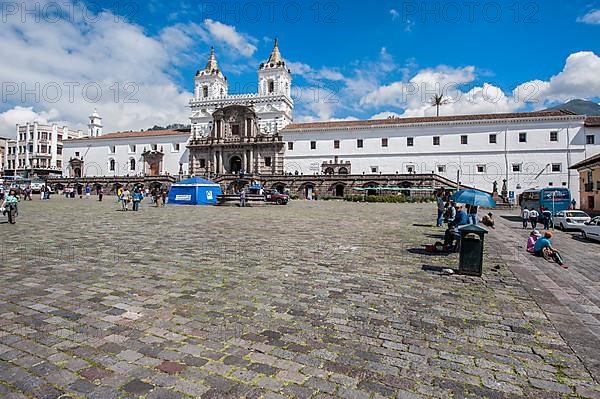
[458,224,488,277]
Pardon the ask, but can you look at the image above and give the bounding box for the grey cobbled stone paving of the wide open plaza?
[0,197,600,399]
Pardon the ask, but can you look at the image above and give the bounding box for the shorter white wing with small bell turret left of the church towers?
[62,112,190,177]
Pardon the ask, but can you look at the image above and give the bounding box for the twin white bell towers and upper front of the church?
[190,39,294,138]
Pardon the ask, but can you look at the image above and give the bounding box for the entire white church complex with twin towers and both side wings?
[48,41,600,202]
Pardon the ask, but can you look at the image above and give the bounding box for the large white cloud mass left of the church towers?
[0,0,254,137]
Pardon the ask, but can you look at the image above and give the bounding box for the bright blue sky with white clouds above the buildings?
[0,0,600,136]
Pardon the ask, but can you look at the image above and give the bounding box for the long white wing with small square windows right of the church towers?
[282,111,600,200]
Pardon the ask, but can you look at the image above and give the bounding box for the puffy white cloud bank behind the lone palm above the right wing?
[360,52,600,116]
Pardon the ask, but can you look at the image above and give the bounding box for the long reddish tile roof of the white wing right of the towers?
[285,110,575,131]
